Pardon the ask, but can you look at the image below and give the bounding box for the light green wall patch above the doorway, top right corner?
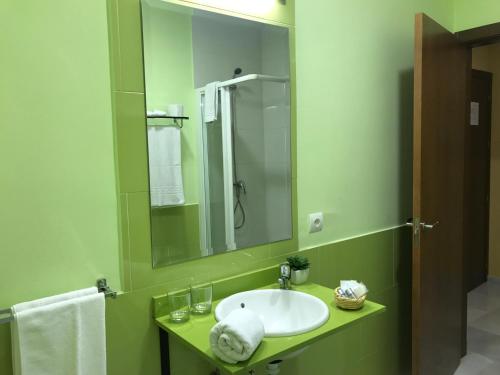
[454,0,500,31]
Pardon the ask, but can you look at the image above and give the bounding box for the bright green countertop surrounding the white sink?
[156,283,385,374]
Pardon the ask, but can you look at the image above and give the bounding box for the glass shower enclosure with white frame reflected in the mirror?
[197,74,292,255]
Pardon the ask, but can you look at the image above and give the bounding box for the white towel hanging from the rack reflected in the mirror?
[148,126,185,207]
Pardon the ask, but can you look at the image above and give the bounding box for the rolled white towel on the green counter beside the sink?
[210,309,264,363]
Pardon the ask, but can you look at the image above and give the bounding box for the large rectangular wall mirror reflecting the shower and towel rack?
[142,0,292,267]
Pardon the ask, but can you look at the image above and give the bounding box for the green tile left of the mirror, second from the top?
[114,92,149,193]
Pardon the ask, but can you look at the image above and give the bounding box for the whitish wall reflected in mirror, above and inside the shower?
[192,12,291,247]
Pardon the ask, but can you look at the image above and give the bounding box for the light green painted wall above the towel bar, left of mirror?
[0,0,120,308]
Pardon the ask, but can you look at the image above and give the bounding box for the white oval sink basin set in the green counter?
[215,289,330,337]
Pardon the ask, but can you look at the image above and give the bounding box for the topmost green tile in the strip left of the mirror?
[117,0,144,93]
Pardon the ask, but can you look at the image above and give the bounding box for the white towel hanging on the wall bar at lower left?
[11,288,106,375]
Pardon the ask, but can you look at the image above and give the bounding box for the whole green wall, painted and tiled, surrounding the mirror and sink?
[0,0,500,375]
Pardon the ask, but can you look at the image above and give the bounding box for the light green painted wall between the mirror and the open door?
[295,0,452,248]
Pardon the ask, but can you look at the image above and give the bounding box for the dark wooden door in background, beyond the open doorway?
[464,70,493,291]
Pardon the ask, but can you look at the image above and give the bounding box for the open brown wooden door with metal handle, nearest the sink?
[412,14,471,375]
